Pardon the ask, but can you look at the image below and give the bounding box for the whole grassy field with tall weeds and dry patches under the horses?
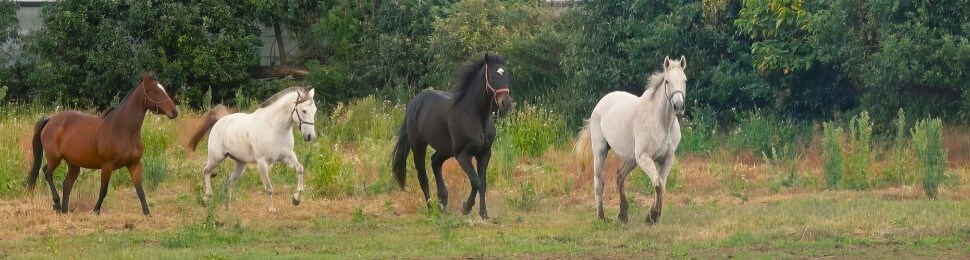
[0,98,970,259]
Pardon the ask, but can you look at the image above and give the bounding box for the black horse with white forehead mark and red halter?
[393,53,512,219]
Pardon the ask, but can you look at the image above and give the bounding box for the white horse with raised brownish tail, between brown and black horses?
[189,87,317,212]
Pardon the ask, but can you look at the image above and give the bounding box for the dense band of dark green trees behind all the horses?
[0,0,970,125]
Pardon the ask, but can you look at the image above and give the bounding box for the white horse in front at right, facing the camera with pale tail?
[575,56,687,224]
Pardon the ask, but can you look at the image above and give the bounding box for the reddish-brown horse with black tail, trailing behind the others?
[27,72,178,215]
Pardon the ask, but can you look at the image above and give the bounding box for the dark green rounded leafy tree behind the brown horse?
[29,0,260,106]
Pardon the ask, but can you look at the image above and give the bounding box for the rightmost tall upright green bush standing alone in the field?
[913,118,947,198]
